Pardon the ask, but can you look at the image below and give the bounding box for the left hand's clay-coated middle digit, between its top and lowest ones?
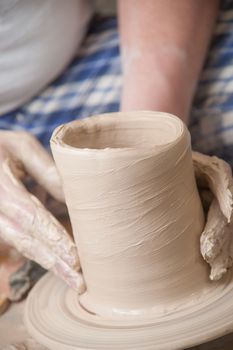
[0,160,80,270]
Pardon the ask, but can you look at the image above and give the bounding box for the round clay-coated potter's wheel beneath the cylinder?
[25,273,233,350]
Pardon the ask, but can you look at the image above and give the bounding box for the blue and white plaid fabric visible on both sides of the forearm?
[0,0,233,166]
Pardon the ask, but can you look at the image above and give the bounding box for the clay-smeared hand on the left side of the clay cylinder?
[0,131,83,292]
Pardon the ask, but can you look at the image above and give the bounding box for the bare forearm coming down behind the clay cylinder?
[118,0,218,122]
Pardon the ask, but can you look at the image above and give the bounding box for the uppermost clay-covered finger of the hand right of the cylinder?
[192,152,233,222]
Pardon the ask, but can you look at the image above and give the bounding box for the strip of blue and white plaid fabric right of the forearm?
[189,0,233,167]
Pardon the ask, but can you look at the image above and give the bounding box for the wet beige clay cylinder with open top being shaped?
[51,112,207,316]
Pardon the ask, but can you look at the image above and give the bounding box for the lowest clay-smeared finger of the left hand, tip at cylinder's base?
[0,213,85,294]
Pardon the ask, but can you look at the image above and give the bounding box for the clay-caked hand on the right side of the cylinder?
[193,152,233,280]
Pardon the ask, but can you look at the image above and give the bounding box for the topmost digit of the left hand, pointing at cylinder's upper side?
[0,131,64,201]
